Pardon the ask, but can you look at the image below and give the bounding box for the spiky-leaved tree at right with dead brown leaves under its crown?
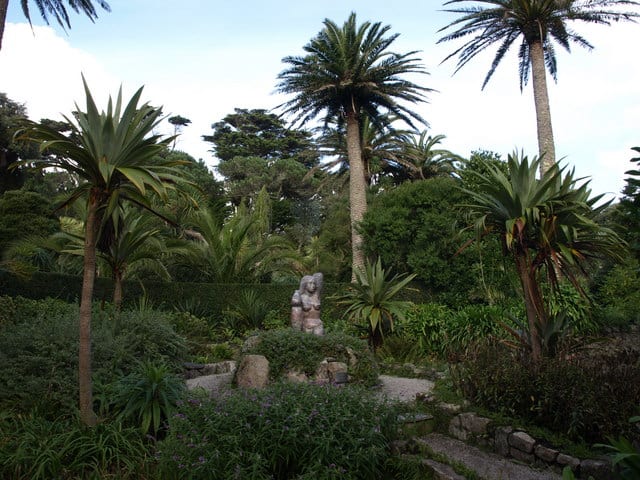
[465,154,624,364]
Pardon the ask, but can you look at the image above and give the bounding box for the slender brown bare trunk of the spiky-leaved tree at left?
[78,192,98,426]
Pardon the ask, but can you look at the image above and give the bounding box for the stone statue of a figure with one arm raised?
[291,273,324,335]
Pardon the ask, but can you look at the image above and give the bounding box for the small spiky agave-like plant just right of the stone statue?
[336,258,415,349]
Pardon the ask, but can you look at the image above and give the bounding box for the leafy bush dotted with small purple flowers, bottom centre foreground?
[158,384,397,480]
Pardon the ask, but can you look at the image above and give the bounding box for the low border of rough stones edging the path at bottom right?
[449,412,612,480]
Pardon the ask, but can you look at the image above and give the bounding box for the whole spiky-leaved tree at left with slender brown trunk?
[20,78,185,425]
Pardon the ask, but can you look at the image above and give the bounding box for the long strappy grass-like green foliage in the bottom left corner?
[0,415,152,480]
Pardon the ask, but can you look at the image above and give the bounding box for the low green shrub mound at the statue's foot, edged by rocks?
[244,328,378,386]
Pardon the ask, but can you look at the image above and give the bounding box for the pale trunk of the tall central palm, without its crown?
[347,113,367,282]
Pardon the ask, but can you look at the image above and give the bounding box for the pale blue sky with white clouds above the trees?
[0,0,640,198]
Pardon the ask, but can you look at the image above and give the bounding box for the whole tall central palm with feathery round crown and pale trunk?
[276,13,430,279]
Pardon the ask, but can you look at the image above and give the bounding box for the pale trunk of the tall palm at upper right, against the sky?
[529,42,556,176]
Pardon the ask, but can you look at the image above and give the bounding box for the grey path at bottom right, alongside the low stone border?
[414,433,562,480]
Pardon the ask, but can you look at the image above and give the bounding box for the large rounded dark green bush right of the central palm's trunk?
[362,177,509,305]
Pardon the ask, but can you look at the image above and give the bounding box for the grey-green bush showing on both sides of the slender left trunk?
[0,300,186,416]
